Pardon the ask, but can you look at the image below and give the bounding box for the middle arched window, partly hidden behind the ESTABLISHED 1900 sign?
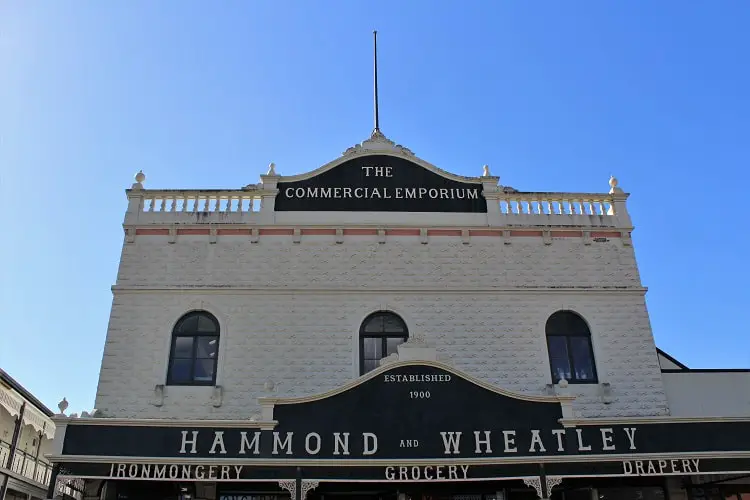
[359,311,409,374]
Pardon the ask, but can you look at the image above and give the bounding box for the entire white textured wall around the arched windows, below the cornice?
[96,236,667,418]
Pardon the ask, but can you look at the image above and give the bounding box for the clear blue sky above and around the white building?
[0,0,750,412]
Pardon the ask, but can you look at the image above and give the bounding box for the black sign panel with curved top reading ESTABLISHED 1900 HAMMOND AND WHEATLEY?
[63,364,750,463]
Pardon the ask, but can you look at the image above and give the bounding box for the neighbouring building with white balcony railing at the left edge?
[0,369,81,500]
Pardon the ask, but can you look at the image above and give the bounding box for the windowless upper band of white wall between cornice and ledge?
[117,236,641,290]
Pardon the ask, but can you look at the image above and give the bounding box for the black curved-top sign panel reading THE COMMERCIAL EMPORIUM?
[275,155,487,213]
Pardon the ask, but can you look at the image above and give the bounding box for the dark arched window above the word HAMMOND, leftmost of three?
[167,311,219,385]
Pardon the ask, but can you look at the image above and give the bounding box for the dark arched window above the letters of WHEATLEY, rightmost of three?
[545,311,597,384]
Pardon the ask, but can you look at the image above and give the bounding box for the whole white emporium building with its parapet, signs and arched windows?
[50,128,750,500]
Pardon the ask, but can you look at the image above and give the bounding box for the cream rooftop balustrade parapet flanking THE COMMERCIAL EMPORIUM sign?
[125,173,632,231]
